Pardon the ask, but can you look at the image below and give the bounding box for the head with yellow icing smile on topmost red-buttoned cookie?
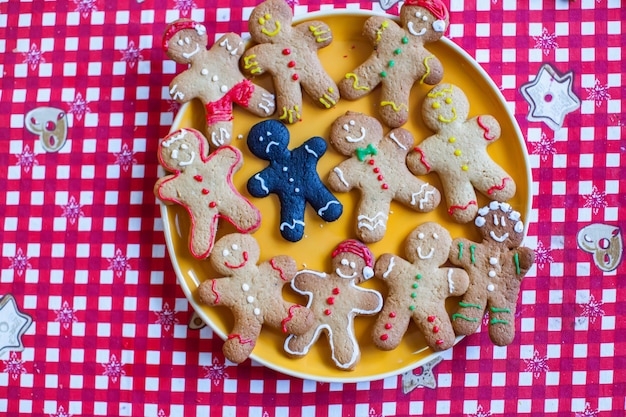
[248,0,293,43]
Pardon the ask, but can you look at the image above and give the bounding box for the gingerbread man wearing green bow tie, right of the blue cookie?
[328,112,441,243]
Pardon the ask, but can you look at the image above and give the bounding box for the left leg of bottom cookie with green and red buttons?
[372,298,411,350]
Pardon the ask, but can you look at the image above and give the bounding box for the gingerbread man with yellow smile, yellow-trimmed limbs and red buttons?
[242,0,339,123]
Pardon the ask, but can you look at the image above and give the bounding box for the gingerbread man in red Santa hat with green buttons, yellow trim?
[339,0,448,127]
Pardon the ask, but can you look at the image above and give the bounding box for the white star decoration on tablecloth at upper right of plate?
[520,64,580,130]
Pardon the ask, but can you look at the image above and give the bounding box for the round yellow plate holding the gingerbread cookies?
[161,11,531,382]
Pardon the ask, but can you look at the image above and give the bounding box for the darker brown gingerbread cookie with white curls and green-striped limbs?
[449,201,535,346]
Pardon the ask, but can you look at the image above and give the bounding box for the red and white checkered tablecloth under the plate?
[0,0,626,417]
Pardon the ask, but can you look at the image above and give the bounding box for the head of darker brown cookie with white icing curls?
[474,201,524,249]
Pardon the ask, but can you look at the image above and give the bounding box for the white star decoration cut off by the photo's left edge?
[0,294,33,356]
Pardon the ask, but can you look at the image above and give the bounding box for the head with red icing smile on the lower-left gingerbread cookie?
[211,233,260,276]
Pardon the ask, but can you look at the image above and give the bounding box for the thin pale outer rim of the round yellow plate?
[157,8,533,383]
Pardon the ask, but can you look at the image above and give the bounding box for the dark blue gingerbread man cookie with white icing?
[248,120,343,242]
